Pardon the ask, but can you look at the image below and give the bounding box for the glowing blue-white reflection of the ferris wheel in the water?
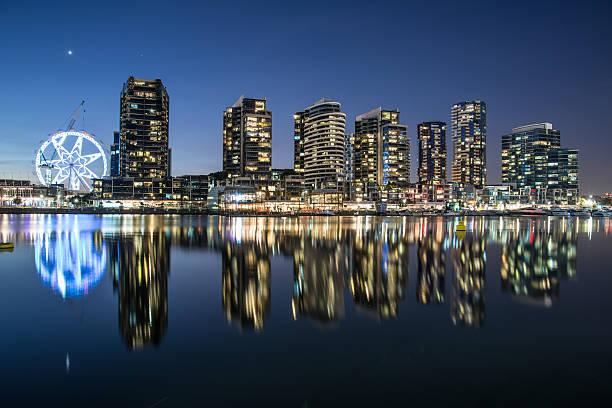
[34,231,108,299]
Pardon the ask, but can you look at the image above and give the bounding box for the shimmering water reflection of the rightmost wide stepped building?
[501,229,577,307]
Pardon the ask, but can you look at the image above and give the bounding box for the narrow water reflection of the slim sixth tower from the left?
[450,234,486,327]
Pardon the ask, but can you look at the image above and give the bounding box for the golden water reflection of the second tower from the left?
[221,242,270,330]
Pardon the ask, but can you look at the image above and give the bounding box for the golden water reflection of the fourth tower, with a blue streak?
[350,223,409,319]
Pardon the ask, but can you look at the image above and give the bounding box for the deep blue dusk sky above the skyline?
[0,0,612,193]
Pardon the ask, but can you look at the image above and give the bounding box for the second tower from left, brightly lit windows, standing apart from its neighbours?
[223,95,272,180]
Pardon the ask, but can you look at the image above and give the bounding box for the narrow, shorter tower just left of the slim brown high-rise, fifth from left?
[417,122,446,185]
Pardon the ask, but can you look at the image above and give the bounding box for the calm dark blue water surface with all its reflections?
[0,215,612,407]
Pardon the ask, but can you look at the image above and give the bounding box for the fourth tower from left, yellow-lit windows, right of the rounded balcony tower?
[354,107,410,199]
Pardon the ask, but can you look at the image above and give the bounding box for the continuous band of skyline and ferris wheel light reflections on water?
[0,215,610,330]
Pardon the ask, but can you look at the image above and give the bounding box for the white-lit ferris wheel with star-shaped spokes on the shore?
[34,130,108,192]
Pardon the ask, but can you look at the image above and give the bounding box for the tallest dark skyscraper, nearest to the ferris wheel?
[119,77,170,178]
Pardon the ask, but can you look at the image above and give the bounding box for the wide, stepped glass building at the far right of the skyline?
[502,123,578,203]
